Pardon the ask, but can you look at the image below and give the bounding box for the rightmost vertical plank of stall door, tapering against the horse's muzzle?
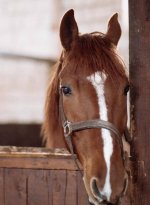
[77,171,89,205]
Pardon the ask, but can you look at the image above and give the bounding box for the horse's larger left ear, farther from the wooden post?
[60,9,78,50]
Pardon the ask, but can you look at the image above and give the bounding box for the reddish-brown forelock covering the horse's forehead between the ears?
[62,32,126,81]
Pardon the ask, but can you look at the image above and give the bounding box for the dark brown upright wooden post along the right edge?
[129,0,150,205]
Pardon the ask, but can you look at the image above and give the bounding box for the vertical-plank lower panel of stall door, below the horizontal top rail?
[0,168,89,205]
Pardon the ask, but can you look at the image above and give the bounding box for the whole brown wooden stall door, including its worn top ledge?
[0,147,89,205]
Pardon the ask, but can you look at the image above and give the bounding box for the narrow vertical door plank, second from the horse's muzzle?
[65,171,77,205]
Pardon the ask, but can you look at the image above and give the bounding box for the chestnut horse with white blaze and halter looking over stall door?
[43,9,129,205]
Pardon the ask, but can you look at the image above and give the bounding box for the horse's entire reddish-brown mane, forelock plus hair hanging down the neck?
[42,32,126,148]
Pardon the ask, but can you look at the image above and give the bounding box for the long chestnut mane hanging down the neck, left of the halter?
[42,61,62,147]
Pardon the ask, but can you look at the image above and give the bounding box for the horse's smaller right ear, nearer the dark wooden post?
[106,13,121,46]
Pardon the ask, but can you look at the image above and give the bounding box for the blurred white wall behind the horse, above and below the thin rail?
[0,0,128,123]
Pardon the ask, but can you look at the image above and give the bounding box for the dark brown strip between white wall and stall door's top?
[0,123,44,147]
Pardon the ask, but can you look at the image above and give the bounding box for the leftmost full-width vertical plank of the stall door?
[4,169,27,205]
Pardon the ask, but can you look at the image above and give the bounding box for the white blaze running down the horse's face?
[87,72,113,201]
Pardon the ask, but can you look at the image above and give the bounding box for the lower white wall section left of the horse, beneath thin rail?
[0,56,50,124]
